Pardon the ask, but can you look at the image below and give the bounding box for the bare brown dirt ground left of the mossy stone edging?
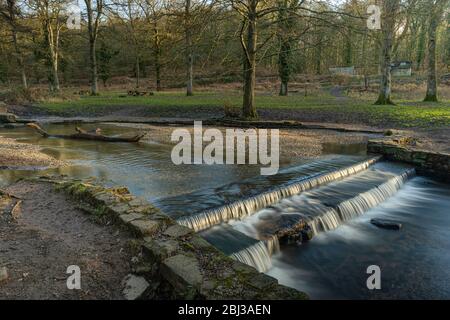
[0,181,132,299]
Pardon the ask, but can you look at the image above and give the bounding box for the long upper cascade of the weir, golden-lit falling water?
[177,157,381,231]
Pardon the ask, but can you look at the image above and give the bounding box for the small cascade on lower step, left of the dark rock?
[231,236,280,272]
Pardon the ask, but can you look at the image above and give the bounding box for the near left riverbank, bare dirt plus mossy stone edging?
[0,129,307,300]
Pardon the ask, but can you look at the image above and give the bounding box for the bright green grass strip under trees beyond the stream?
[39,92,450,128]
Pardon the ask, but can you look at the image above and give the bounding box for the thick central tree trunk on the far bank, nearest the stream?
[241,0,258,118]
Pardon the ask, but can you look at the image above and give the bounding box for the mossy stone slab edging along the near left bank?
[38,177,308,300]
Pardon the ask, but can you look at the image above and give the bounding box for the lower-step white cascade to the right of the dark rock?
[307,169,415,234]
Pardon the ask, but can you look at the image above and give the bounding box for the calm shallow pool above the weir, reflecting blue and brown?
[0,125,278,201]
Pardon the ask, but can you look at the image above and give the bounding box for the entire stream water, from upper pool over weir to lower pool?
[0,125,450,299]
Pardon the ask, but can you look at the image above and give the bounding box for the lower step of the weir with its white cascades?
[223,168,415,272]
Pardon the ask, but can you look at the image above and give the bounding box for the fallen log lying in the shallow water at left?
[27,123,145,142]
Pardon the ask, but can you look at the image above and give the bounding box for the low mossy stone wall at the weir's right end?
[367,139,450,182]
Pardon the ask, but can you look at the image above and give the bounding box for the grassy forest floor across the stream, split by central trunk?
[9,89,450,130]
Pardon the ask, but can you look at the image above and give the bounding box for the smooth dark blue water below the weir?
[269,177,450,299]
